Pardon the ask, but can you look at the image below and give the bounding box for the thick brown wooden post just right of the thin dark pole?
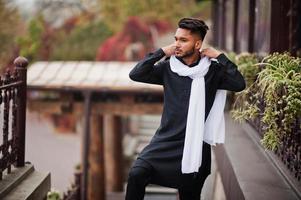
[88,114,106,200]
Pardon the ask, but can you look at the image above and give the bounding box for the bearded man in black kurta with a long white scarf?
[126,18,245,200]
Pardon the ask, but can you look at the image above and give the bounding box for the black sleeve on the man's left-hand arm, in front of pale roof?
[129,49,165,85]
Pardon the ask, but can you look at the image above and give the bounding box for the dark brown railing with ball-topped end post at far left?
[0,57,28,180]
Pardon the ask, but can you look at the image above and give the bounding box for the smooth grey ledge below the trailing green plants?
[214,114,299,200]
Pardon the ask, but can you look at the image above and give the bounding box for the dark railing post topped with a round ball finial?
[14,57,28,167]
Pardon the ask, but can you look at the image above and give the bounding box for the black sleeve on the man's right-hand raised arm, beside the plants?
[217,54,246,92]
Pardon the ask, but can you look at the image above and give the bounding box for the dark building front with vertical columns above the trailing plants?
[212,0,301,56]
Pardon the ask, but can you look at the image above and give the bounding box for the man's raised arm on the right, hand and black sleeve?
[200,48,246,92]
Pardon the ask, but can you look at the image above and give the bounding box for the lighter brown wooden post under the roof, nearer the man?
[104,114,123,192]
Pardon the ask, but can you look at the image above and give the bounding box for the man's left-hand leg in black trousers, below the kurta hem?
[125,166,152,200]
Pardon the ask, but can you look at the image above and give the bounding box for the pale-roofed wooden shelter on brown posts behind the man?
[27,61,163,200]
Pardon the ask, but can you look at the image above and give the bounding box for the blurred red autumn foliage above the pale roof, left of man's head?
[96,17,171,61]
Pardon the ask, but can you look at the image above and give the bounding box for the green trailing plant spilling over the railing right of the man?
[232,53,301,150]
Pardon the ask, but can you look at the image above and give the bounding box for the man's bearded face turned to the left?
[175,28,202,58]
